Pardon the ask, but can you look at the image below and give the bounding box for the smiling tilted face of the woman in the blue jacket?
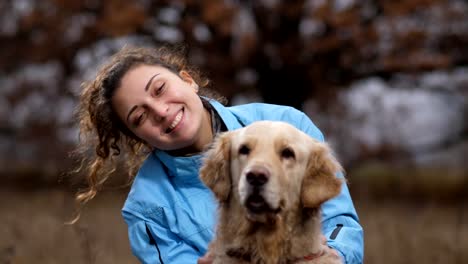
[112,65,212,151]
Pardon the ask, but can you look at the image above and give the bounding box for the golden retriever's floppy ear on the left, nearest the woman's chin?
[200,132,232,202]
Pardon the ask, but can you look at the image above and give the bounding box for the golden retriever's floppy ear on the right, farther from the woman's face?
[301,141,343,208]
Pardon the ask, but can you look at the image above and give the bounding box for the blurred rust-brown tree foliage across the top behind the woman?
[0,0,468,180]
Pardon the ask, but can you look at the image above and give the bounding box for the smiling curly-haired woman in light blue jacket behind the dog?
[77,44,363,263]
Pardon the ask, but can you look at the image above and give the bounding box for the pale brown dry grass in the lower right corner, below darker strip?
[355,199,468,264]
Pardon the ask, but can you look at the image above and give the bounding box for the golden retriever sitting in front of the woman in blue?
[200,121,342,264]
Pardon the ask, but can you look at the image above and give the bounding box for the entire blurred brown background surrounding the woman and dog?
[0,0,468,263]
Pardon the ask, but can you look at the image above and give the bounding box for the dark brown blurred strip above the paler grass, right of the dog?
[347,162,468,203]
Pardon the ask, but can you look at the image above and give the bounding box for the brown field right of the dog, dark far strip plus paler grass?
[348,163,468,264]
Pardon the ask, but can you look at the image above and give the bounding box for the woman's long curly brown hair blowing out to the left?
[69,46,226,224]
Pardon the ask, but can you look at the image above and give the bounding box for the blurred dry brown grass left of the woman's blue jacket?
[0,188,138,264]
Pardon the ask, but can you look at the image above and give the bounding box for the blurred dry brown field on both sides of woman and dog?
[0,180,468,264]
